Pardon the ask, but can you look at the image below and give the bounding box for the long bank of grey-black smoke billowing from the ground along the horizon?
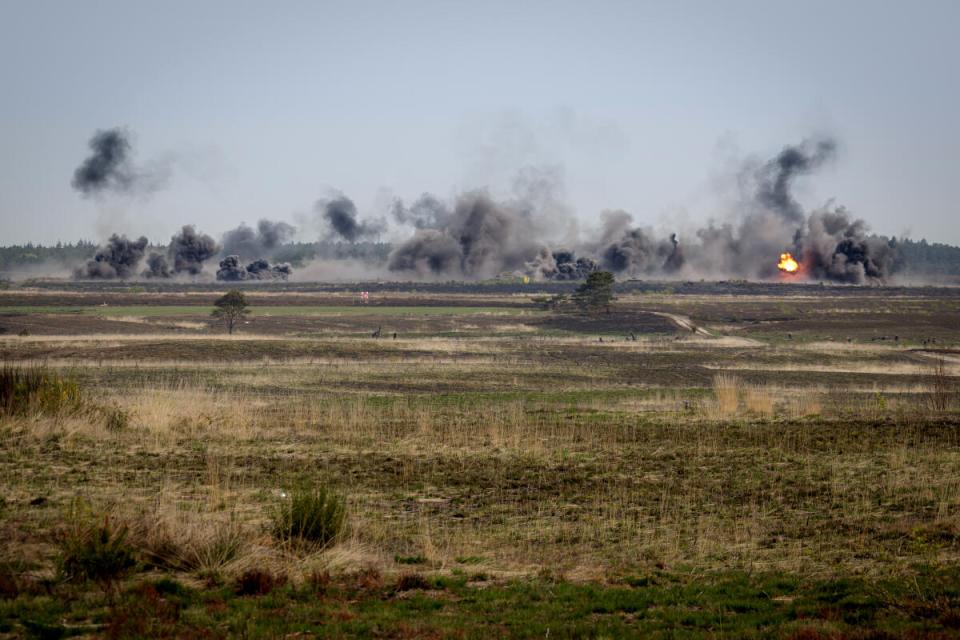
[69,138,900,283]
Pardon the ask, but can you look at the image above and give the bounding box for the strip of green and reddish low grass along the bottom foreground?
[0,569,960,638]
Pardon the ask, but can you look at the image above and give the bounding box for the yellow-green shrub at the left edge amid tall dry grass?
[0,365,83,415]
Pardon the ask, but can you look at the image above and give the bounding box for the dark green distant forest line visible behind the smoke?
[0,236,960,276]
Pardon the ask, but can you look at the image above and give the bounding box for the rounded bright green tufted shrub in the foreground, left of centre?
[273,487,347,547]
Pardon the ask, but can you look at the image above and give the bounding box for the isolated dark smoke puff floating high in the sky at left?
[71,128,169,196]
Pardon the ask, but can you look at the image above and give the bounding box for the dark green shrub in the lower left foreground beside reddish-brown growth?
[57,510,136,587]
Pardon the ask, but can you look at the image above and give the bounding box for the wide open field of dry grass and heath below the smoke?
[0,283,960,638]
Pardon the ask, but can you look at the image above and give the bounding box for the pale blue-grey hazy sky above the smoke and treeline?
[0,0,960,245]
